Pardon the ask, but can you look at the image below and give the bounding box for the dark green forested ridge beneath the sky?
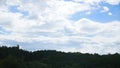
[0,46,120,68]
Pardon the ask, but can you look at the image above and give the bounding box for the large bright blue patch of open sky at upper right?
[71,3,120,23]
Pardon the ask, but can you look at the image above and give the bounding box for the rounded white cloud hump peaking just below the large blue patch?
[75,18,104,34]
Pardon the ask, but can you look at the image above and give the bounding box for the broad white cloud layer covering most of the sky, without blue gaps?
[0,0,120,53]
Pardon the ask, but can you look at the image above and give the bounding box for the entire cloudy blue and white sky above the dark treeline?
[0,0,120,54]
